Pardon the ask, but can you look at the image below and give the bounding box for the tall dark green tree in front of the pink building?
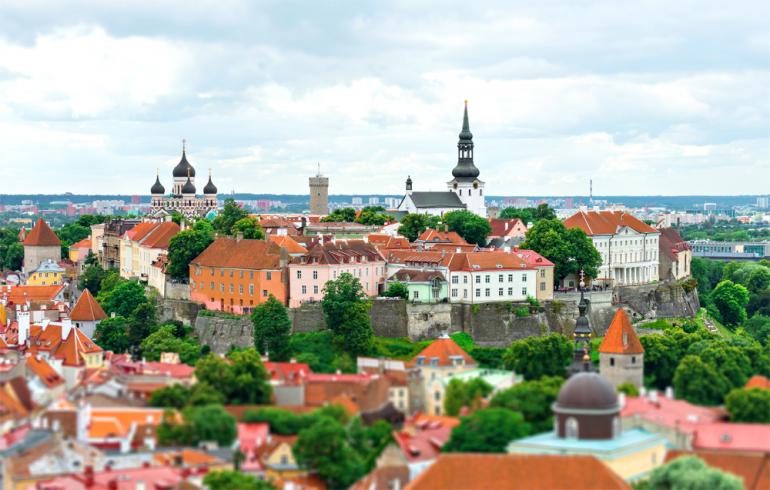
[321,273,374,355]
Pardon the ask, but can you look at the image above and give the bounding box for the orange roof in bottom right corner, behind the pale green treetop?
[665,449,770,490]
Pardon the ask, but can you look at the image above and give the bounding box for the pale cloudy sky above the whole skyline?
[0,0,770,196]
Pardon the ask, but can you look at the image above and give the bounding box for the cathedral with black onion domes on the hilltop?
[149,141,217,219]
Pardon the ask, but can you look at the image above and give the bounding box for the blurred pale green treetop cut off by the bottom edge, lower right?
[648,456,743,490]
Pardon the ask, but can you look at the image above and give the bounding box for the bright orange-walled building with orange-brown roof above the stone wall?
[190,238,288,315]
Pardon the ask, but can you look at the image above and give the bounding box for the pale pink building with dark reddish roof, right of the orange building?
[289,240,385,308]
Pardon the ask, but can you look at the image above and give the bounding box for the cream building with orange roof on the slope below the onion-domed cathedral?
[120,221,180,281]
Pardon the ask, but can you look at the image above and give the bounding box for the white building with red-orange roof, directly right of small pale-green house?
[449,252,537,304]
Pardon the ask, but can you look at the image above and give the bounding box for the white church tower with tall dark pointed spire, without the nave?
[447,100,487,218]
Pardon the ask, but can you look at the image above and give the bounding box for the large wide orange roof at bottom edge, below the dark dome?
[405,453,631,490]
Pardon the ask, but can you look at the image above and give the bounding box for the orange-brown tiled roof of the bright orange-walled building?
[190,238,281,269]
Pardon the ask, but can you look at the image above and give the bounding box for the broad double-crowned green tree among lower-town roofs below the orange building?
[195,349,272,405]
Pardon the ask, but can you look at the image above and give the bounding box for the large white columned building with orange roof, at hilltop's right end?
[564,211,660,285]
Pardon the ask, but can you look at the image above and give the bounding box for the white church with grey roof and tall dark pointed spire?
[398,100,487,218]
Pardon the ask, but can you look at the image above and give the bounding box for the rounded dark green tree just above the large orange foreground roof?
[442,408,531,453]
